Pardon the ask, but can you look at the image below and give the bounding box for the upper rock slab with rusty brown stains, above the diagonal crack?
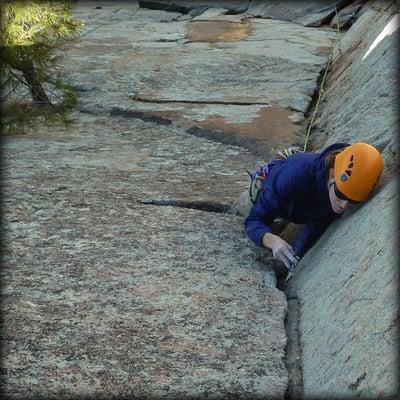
[64,2,336,159]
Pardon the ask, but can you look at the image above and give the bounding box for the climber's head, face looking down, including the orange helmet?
[328,143,383,214]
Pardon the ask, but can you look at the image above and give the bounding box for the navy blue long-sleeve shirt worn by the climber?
[245,143,349,257]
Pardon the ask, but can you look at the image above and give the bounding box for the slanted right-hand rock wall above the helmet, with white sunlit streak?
[313,3,400,175]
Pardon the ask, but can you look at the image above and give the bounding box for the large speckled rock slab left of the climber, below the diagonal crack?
[2,114,288,398]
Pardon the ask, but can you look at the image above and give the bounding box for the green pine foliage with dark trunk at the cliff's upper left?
[0,0,83,133]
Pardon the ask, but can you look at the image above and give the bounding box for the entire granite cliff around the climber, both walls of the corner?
[1,1,399,399]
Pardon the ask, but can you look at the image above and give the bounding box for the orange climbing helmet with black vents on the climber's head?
[333,143,383,201]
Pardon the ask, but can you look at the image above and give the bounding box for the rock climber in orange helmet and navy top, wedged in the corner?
[234,143,383,273]
